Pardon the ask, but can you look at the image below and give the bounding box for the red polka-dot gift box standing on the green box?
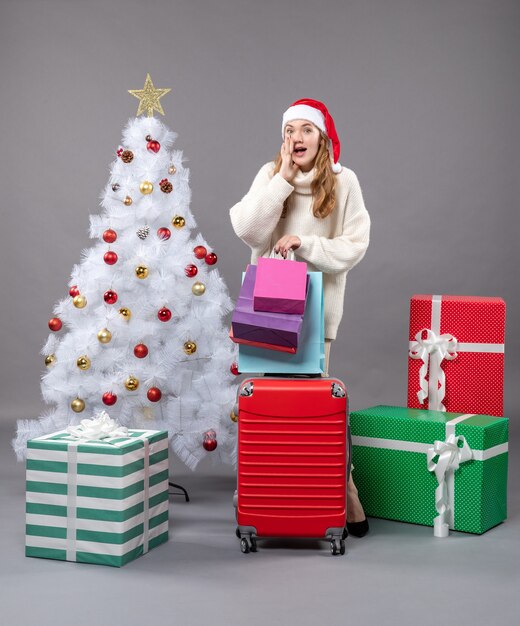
[408,295,506,416]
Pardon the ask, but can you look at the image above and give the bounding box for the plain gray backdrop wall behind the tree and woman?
[0,0,520,432]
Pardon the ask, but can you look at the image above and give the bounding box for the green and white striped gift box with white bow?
[25,430,168,567]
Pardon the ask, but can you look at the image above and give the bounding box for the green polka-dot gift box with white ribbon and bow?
[350,406,509,536]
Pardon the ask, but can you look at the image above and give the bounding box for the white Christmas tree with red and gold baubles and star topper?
[13,75,237,468]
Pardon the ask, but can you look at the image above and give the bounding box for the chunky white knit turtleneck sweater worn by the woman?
[229,162,370,339]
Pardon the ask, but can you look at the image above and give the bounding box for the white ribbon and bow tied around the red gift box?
[408,295,504,411]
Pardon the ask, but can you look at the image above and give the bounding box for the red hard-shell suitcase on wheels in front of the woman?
[235,378,350,554]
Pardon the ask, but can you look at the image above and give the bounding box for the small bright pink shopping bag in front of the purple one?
[253,257,307,315]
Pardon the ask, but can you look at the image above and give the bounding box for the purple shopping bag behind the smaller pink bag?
[231,265,303,350]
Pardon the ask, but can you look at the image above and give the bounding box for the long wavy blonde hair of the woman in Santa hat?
[273,131,336,219]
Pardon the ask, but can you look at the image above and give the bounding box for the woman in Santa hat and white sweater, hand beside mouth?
[230,99,370,537]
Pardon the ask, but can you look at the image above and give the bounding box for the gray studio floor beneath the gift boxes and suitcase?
[0,414,520,626]
